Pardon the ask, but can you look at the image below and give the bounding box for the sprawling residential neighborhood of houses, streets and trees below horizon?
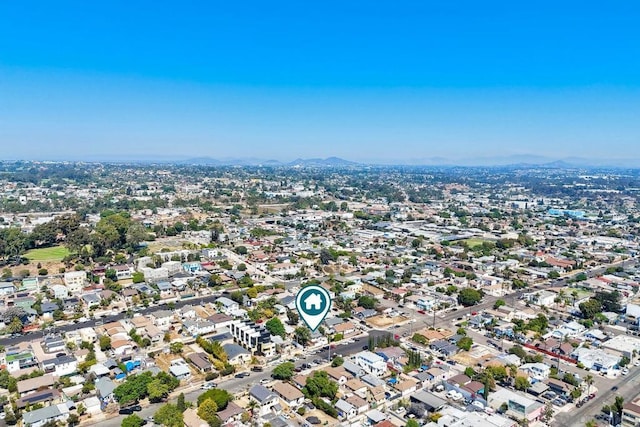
[0,162,640,427]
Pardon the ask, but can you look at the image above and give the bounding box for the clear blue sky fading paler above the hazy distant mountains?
[0,0,640,161]
